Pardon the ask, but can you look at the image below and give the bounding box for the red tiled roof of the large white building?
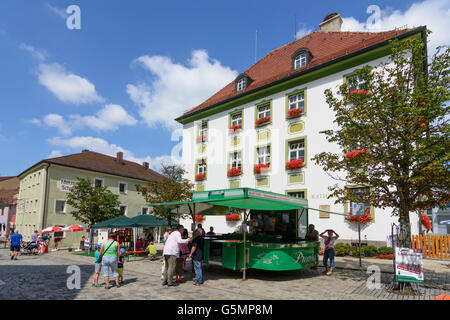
[180,29,418,118]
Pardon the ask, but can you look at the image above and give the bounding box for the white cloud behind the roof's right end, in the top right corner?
[342,0,450,55]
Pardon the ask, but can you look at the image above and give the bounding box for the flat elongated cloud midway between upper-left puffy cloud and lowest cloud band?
[34,104,137,135]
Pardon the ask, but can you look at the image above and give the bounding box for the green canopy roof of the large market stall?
[148,188,308,214]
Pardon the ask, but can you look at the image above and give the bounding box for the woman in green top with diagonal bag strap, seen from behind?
[100,232,120,289]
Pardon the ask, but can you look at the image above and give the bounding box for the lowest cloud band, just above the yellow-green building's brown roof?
[47,136,179,170]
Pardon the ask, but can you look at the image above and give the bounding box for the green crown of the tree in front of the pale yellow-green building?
[67,178,121,226]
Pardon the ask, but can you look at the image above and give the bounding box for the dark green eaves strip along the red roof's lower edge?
[175,26,426,124]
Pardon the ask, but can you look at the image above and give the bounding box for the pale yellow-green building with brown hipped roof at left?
[16,150,162,247]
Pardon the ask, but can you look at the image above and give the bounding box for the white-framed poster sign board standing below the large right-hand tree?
[395,248,424,283]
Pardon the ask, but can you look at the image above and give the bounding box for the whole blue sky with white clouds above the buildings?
[0,0,450,176]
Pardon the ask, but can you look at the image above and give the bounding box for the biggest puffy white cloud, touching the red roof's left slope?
[127,50,238,128]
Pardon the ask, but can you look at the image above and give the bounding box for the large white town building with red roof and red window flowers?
[176,14,425,244]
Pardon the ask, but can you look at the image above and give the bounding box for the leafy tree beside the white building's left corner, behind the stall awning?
[136,163,194,226]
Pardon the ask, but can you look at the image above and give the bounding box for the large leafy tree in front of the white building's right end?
[313,38,450,247]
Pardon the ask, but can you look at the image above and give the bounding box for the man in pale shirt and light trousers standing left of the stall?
[162,225,192,287]
